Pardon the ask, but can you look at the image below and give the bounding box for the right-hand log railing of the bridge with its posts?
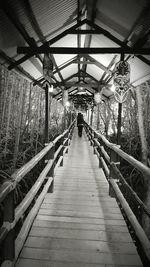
[85,123,150,262]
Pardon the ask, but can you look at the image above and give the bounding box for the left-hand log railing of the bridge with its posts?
[0,121,75,266]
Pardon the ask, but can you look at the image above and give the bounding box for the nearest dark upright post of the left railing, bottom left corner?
[3,189,15,266]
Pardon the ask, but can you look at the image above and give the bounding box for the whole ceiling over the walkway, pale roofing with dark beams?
[0,0,150,109]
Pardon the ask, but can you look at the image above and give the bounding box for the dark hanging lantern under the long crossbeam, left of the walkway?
[43,54,53,78]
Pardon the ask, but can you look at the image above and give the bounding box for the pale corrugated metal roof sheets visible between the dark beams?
[0,0,150,99]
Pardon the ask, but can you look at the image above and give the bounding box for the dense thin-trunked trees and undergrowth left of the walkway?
[0,63,63,192]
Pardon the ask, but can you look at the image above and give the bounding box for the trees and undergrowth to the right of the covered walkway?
[93,84,150,203]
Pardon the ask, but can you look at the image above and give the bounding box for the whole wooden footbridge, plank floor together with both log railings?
[0,123,150,267]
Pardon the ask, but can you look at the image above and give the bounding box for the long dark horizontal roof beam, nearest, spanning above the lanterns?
[17,45,150,55]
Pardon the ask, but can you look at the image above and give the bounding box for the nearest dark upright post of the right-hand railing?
[109,149,120,197]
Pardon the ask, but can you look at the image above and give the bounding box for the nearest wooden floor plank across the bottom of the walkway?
[18,247,140,266]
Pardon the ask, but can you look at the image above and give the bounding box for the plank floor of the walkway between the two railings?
[16,129,143,267]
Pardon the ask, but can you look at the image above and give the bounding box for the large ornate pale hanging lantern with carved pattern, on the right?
[113,61,130,103]
